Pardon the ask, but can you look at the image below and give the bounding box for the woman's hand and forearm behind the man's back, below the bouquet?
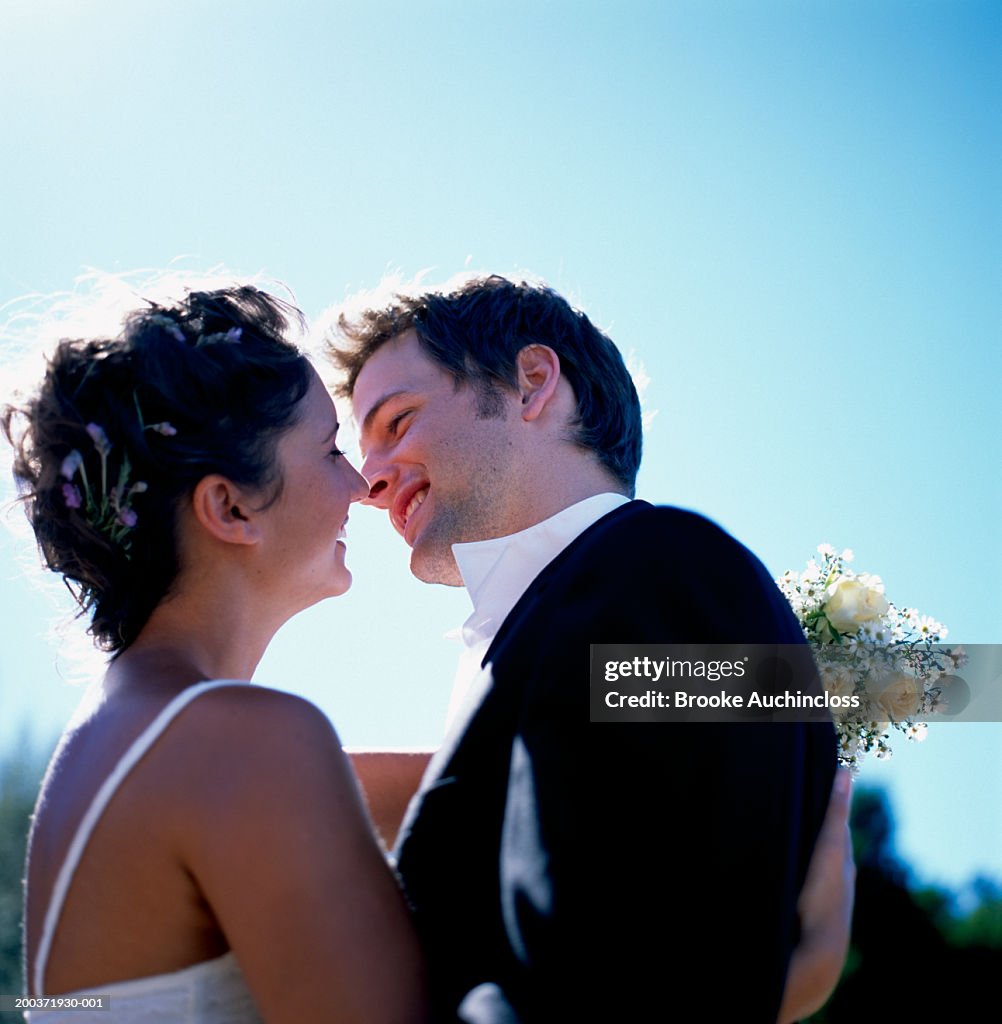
[778,768,856,1024]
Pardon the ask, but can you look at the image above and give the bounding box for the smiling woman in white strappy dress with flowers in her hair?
[3,287,425,1024]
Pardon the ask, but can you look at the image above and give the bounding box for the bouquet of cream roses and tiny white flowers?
[776,544,966,772]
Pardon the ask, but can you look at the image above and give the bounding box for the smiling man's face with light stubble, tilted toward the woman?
[352,331,528,586]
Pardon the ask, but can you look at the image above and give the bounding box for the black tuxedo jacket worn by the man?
[397,502,835,1024]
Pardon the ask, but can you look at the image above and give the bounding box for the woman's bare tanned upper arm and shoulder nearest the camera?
[177,686,427,1024]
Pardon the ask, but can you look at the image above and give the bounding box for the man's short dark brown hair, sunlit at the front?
[328,274,642,495]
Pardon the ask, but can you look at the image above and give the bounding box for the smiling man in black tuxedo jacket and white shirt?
[332,276,847,1024]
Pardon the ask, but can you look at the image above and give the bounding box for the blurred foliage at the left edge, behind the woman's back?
[0,740,45,994]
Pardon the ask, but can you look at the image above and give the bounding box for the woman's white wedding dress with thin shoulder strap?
[25,680,261,1024]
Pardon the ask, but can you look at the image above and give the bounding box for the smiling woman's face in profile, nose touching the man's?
[261,372,368,610]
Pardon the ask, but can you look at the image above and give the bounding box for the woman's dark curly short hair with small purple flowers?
[0,286,311,652]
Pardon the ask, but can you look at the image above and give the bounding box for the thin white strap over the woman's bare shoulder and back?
[35,679,248,995]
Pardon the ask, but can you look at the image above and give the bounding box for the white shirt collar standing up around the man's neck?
[452,493,629,647]
